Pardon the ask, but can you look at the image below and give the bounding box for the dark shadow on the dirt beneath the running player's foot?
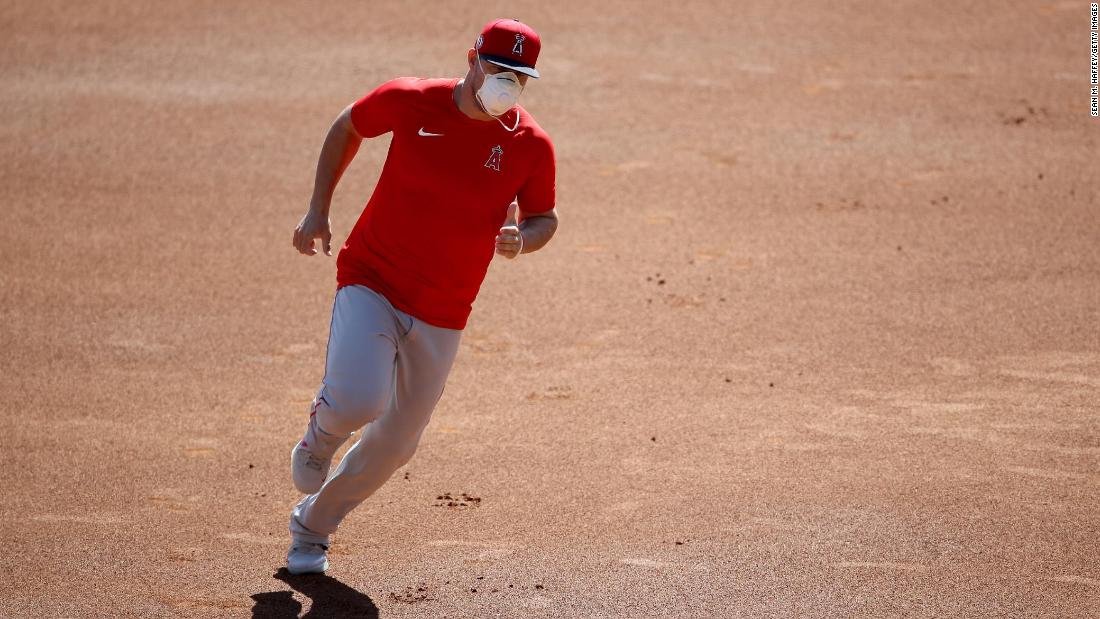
[252,567,378,619]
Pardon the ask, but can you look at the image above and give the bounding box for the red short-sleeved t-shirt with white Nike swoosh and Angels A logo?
[337,77,554,329]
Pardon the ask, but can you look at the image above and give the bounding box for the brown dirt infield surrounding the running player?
[0,0,1100,618]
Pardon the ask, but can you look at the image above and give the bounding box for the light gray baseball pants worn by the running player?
[290,286,462,544]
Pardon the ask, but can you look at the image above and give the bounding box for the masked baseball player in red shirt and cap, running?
[287,20,558,574]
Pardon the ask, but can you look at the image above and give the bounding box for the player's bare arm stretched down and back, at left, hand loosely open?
[294,106,363,256]
